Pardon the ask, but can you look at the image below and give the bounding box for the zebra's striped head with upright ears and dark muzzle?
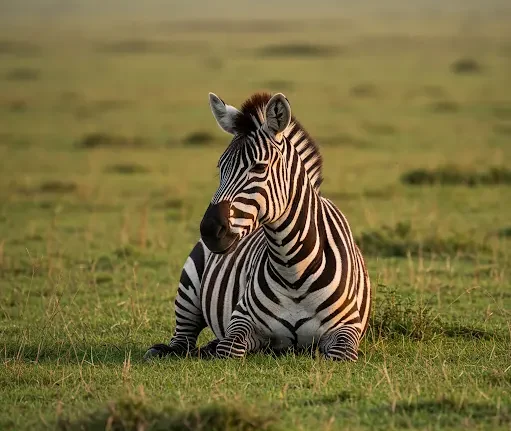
[200,93,296,254]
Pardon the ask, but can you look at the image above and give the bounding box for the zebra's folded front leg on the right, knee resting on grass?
[319,325,360,362]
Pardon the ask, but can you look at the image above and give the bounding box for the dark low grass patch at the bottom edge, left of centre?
[57,397,274,431]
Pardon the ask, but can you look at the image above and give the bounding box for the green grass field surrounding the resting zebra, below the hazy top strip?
[0,5,511,431]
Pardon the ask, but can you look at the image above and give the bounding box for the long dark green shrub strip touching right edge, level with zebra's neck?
[401,165,511,187]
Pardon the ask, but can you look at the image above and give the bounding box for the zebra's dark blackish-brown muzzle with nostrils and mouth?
[200,201,239,254]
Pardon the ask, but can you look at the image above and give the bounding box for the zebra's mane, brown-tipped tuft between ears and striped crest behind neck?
[234,93,323,192]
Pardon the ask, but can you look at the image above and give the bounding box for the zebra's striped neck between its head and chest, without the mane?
[263,156,325,290]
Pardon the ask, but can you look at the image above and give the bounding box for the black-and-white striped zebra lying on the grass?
[145,93,371,361]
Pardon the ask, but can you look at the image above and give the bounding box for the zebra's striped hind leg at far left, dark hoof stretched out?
[144,242,210,360]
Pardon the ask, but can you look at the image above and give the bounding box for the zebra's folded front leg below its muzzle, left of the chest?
[216,312,265,358]
